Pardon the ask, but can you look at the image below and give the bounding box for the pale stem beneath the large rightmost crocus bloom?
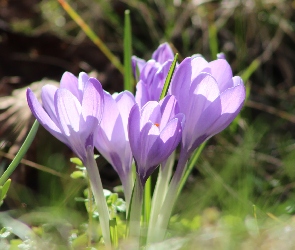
[148,150,189,243]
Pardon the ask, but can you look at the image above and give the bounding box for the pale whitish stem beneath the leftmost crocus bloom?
[84,146,111,247]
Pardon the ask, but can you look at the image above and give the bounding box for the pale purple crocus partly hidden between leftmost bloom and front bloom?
[95,91,135,204]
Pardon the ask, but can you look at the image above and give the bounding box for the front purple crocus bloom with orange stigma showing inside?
[128,95,184,184]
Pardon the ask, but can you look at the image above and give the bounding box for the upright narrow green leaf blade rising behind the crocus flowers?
[124,10,133,93]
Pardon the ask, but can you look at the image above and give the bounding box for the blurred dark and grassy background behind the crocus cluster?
[0,0,295,246]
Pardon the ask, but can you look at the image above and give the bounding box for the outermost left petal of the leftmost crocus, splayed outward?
[27,88,67,144]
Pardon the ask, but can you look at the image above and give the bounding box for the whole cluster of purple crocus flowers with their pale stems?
[27,43,245,247]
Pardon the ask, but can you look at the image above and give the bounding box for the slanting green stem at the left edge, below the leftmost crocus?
[0,120,39,186]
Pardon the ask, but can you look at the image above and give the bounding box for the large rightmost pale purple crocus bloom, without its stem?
[170,57,245,153]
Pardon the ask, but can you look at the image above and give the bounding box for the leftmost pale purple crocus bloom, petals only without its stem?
[27,72,103,161]
